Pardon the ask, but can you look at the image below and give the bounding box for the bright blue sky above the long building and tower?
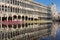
[34,0,60,12]
